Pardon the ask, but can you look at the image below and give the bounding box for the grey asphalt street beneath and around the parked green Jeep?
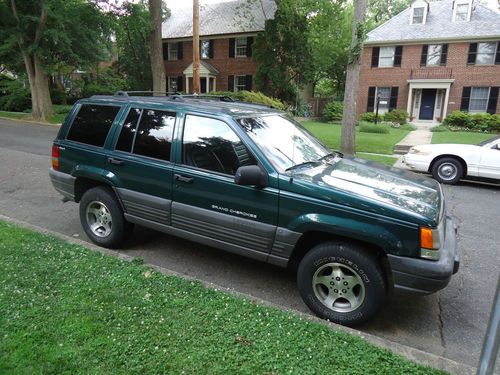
[0,119,500,370]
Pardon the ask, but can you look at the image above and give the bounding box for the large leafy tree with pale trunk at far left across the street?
[0,0,111,120]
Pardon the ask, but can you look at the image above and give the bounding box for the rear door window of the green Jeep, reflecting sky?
[116,108,176,161]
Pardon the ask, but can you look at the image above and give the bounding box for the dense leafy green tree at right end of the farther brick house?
[253,0,313,102]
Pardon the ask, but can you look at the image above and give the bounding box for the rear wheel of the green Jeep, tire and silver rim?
[80,186,127,248]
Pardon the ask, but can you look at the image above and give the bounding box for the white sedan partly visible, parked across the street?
[403,136,500,184]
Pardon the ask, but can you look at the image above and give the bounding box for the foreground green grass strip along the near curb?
[0,221,441,374]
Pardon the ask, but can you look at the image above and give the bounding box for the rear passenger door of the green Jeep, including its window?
[106,106,176,226]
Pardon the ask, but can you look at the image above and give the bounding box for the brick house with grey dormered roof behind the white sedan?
[357,0,500,122]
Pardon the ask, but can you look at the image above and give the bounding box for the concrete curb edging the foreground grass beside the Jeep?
[0,214,476,375]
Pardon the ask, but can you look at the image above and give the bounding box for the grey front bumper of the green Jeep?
[387,216,460,295]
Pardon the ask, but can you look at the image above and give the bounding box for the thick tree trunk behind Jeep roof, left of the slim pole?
[149,0,167,95]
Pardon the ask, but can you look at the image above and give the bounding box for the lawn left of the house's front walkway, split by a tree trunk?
[302,121,410,155]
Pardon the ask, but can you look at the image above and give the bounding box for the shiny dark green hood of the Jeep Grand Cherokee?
[294,157,442,225]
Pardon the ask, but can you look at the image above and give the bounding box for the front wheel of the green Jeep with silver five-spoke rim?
[297,242,386,326]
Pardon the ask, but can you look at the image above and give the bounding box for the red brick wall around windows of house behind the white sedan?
[357,42,500,119]
